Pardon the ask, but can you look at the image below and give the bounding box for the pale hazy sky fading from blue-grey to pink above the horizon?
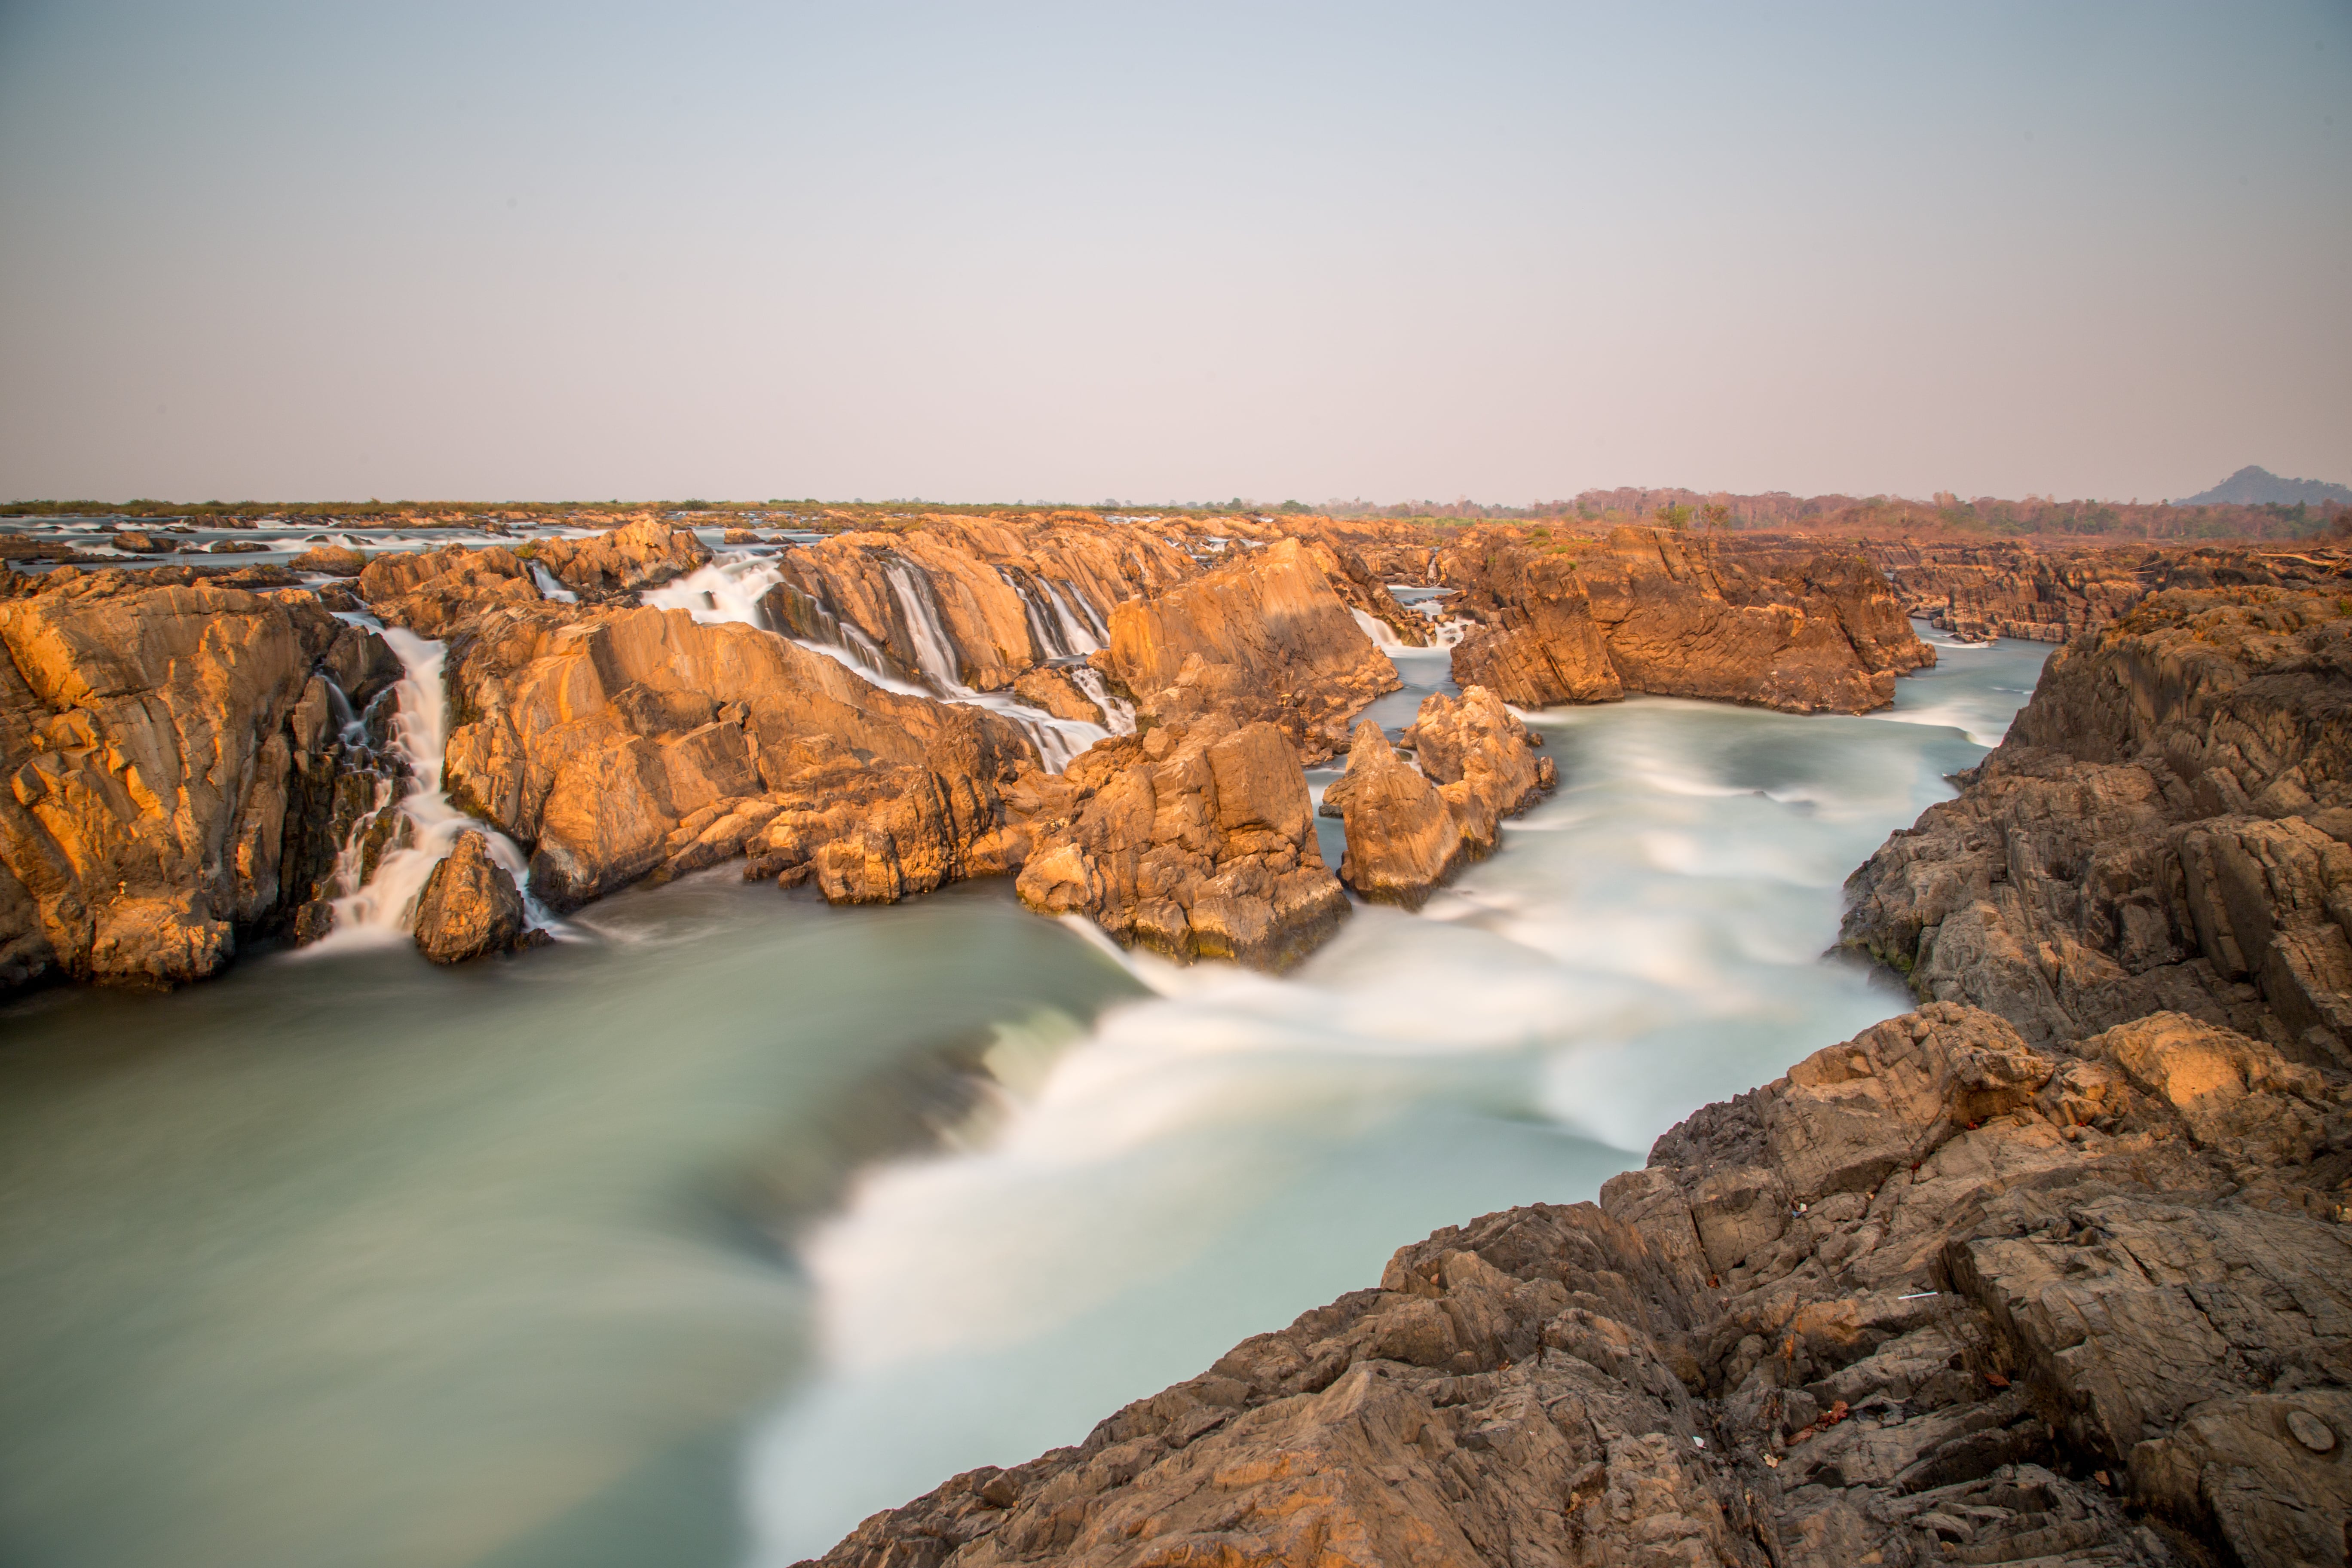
[0,0,2352,501]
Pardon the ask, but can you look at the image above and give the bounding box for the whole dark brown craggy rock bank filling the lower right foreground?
[821,590,2352,1568]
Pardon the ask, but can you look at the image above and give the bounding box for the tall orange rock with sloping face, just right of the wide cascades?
[1110,538,1402,762]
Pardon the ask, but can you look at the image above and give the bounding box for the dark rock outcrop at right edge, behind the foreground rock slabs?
[1844,588,2352,1065]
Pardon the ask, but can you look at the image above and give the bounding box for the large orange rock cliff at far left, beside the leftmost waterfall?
[0,567,398,985]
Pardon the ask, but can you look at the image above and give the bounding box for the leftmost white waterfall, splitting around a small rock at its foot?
[306,625,555,952]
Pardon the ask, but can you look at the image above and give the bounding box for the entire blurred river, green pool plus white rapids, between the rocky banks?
[0,625,2046,1568]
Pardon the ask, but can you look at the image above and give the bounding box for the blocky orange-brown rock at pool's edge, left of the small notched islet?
[1016,715,1348,968]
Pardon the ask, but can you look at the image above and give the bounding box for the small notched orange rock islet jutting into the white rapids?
[1322,686,1559,907]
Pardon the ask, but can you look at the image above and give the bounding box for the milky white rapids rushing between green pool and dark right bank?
[746,640,2046,1568]
